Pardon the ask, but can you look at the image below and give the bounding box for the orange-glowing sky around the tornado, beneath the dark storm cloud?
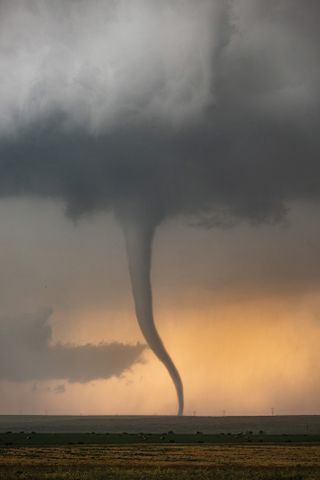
[0,200,320,415]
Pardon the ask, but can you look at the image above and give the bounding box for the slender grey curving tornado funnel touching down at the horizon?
[120,204,184,415]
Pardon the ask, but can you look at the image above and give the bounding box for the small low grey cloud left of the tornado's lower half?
[0,311,145,384]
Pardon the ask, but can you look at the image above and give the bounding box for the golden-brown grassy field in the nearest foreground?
[0,444,320,480]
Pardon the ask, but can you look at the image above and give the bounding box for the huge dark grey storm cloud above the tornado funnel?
[0,0,320,225]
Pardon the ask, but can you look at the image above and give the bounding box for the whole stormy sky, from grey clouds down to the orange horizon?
[0,0,320,415]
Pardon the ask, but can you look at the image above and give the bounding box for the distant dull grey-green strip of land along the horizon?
[0,415,320,435]
